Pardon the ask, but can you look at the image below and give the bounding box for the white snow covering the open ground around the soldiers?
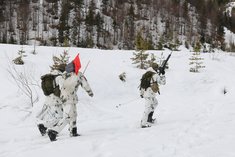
[0,44,235,157]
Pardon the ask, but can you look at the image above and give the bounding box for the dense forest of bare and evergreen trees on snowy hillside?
[0,0,235,50]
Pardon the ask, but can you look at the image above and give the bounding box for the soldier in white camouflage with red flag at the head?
[48,56,93,141]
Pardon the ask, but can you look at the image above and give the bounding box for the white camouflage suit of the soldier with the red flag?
[50,72,93,136]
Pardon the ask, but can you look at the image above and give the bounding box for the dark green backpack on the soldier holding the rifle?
[140,71,159,93]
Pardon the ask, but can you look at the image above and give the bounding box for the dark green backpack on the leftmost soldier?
[41,74,60,97]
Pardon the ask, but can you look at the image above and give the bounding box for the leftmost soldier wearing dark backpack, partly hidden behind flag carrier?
[37,64,66,136]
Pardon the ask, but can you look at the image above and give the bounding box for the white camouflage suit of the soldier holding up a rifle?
[140,67,166,127]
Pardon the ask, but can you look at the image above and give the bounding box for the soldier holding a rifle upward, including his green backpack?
[140,63,166,128]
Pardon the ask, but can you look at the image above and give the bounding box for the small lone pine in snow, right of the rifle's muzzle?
[189,42,205,72]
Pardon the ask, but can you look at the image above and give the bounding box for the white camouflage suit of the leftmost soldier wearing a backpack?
[36,70,63,131]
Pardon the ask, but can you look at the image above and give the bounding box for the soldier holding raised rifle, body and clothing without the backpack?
[140,64,166,128]
